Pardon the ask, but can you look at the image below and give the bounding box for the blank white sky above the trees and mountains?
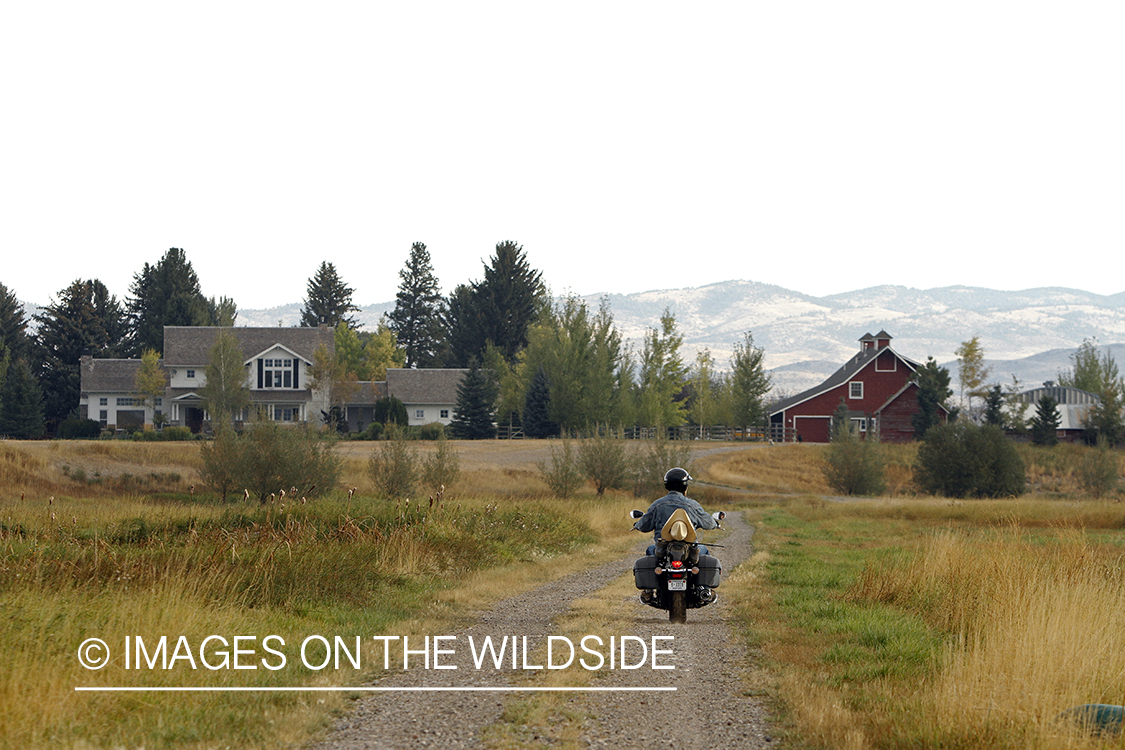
[0,0,1125,308]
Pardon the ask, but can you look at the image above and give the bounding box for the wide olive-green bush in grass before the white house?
[200,422,341,501]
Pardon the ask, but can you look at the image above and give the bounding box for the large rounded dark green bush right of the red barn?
[914,422,1026,497]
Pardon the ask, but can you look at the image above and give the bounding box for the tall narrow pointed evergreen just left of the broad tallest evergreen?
[387,242,442,368]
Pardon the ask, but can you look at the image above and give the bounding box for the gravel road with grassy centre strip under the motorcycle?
[313,515,780,750]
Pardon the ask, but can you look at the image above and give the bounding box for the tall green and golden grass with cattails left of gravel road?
[0,488,598,747]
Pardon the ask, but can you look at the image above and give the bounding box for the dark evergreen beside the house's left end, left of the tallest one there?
[35,279,127,425]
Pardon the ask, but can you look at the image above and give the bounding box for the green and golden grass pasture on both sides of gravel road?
[0,441,1125,748]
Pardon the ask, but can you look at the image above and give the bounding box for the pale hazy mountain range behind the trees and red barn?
[237,281,1125,394]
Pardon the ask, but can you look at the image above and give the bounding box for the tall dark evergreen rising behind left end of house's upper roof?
[126,247,214,356]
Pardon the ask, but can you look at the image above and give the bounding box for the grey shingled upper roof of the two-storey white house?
[164,326,335,367]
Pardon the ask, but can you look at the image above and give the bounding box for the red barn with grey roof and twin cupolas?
[770,331,946,443]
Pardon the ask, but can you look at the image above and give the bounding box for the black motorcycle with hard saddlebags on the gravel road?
[629,508,727,623]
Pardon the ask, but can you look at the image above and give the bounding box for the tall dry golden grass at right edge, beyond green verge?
[849,532,1125,748]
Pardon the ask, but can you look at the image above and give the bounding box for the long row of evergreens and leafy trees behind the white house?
[0,241,771,437]
